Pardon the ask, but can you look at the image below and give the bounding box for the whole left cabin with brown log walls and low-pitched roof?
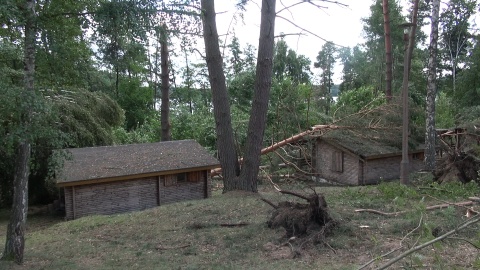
[57,140,220,220]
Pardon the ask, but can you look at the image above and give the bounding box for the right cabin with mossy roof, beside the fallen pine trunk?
[312,130,425,185]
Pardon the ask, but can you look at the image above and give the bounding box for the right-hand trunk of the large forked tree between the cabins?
[240,0,276,192]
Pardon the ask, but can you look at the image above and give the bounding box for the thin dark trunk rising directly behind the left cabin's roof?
[160,28,172,141]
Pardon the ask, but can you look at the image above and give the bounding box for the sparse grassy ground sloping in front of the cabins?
[0,174,480,269]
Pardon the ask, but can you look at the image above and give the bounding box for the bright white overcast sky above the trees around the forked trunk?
[215,0,373,80]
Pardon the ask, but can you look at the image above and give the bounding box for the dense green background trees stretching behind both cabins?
[0,0,480,206]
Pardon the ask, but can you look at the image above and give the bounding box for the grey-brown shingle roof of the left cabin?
[57,140,220,185]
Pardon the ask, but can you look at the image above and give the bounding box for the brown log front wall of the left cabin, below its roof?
[64,171,211,220]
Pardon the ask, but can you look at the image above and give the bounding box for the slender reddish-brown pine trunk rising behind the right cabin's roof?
[383,0,393,102]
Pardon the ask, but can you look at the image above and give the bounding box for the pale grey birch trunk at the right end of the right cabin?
[425,0,440,171]
